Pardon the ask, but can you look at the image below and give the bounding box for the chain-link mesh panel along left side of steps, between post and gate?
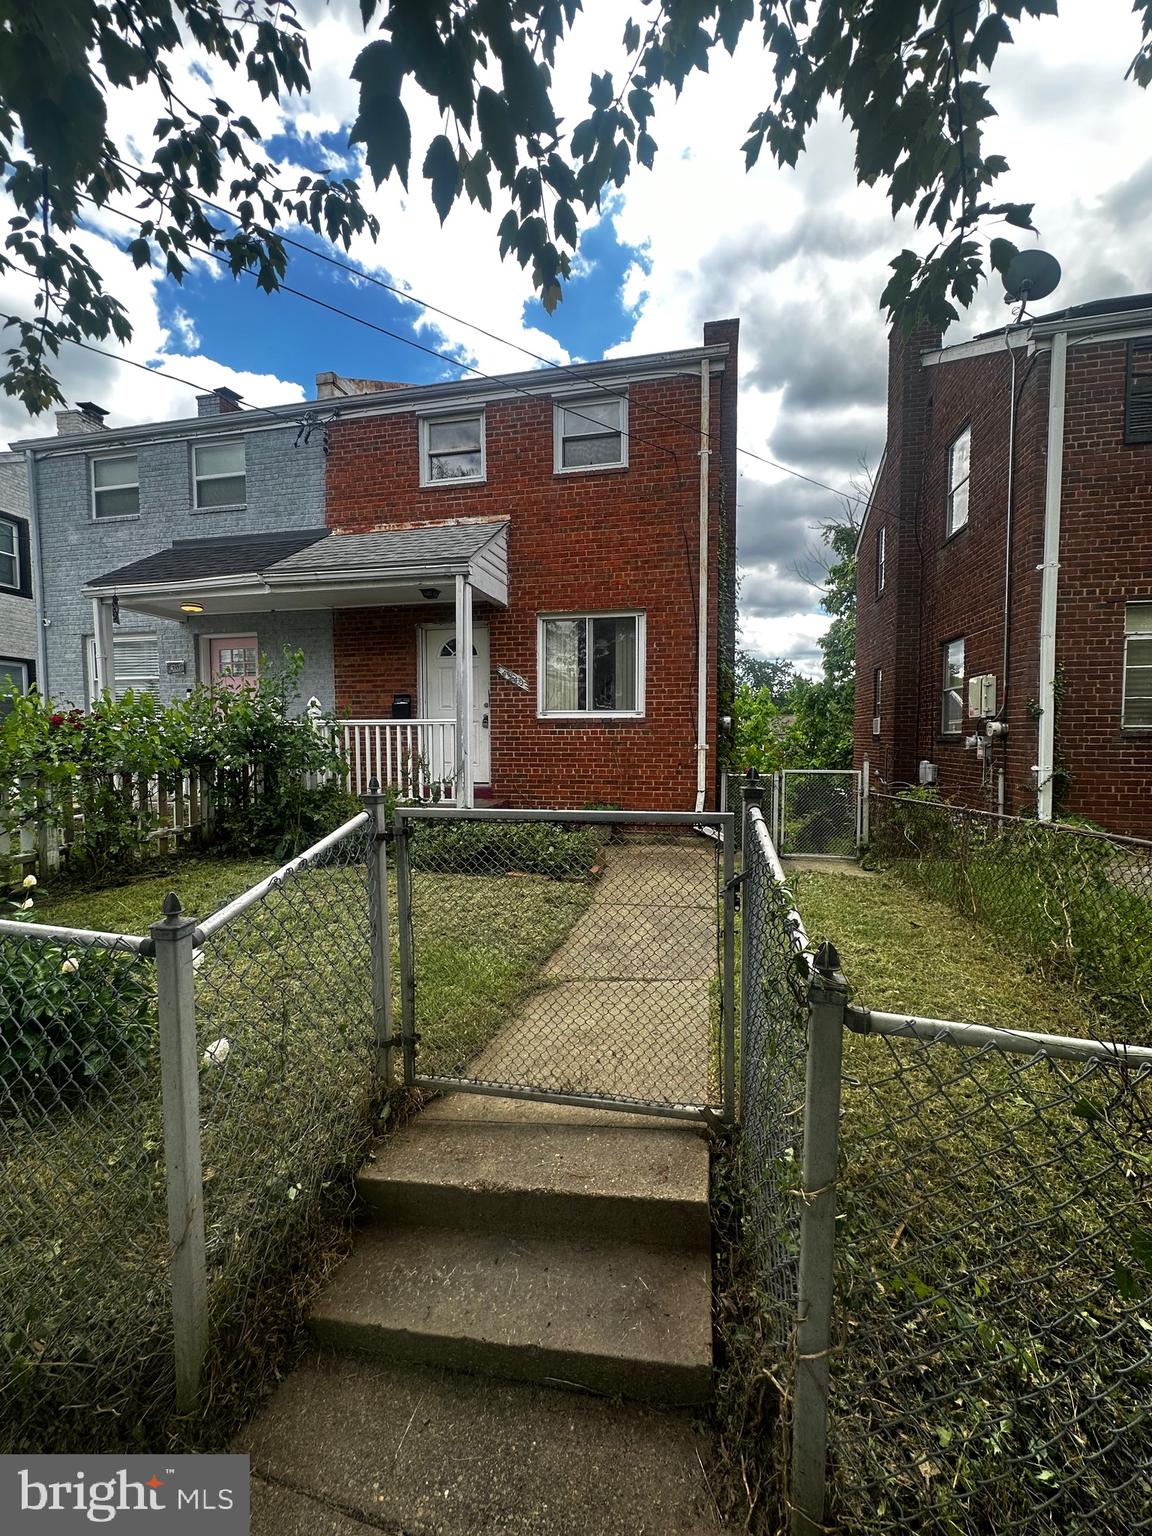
[194,817,379,1350]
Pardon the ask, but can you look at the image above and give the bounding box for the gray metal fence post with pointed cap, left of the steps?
[149,892,207,1413]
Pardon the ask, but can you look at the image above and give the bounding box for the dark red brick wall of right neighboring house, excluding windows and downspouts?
[856,304,1152,836]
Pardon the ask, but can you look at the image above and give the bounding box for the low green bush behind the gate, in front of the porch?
[409,822,604,880]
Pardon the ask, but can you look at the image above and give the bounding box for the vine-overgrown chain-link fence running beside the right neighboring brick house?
[869,794,1152,1044]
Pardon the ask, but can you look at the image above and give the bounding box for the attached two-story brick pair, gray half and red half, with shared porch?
[15,321,739,809]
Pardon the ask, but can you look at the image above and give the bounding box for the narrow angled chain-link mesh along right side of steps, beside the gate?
[739,808,808,1350]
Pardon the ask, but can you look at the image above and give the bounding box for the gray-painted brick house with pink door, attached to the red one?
[22,390,333,707]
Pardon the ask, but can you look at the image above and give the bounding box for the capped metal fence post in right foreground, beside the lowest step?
[790,942,848,1536]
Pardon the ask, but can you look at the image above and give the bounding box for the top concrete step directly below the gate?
[356,1112,710,1252]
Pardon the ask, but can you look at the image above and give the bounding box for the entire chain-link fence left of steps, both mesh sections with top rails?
[0,814,379,1453]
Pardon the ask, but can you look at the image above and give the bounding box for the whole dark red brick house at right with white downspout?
[856,295,1152,837]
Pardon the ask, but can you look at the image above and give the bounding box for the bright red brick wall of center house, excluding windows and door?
[327,321,737,809]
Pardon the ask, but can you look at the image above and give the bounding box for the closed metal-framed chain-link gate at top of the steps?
[395,806,734,1118]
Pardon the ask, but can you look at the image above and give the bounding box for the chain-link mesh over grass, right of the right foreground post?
[829,1032,1152,1536]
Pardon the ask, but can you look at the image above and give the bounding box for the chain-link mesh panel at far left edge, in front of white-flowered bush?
[0,923,172,1453]
